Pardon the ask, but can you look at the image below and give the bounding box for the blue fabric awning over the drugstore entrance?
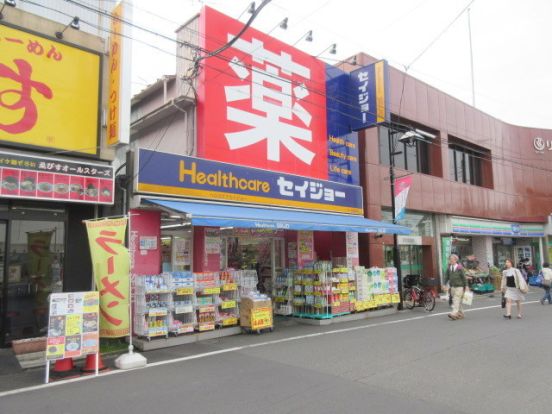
[145,198,410,234]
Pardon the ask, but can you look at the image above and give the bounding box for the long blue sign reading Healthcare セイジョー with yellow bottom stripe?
[136,149,363,215]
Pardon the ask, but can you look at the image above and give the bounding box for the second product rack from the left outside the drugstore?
[169,272,196,335]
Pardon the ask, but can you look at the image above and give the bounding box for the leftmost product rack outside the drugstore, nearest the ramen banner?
[134,273,173,340]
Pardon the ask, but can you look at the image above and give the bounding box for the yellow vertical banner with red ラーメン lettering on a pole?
[85,218,130,338]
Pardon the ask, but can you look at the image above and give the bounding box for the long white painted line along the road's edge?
[0,300,540,398]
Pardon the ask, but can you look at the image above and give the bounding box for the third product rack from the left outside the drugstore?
[194,272,220,332]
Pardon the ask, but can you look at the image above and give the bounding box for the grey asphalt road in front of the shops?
[0,291,552,414]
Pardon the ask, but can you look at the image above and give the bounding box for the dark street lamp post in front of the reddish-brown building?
[387,124,424,310]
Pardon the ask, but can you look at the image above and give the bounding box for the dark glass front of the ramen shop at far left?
[0,209,65,345]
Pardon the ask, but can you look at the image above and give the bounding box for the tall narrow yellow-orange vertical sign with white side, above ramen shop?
[107,1,132,145]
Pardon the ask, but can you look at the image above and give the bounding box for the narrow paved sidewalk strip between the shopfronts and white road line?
[0,289,516,392]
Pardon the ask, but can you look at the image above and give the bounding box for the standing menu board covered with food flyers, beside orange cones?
[46,292,100,361]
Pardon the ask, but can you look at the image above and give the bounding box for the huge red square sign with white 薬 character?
[197,7,328,179]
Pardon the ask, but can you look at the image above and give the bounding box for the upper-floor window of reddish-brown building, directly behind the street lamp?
[379,127,431,174]
